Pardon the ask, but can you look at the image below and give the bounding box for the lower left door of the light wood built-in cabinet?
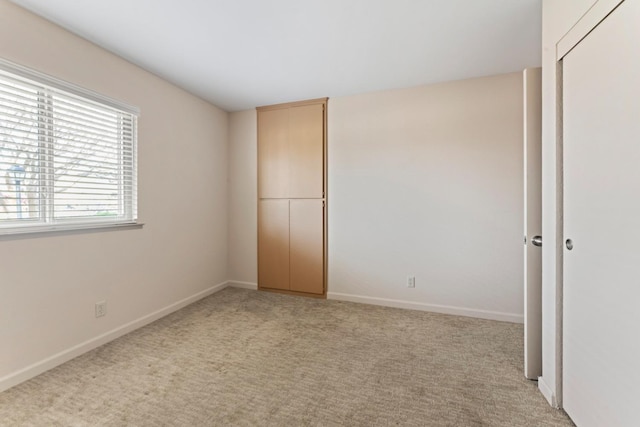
[258,199,289,290]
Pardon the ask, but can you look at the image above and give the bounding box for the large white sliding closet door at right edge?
[562,0,640,427]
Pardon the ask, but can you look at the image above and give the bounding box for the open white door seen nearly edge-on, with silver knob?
[523,68,542,380]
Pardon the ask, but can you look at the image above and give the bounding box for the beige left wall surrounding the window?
[0,0,227,389]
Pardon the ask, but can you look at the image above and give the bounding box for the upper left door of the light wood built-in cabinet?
[258,108,290,199]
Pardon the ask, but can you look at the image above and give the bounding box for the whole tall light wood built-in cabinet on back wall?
[257,98,327,297]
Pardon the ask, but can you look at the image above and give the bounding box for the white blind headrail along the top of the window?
[0,58,140,116]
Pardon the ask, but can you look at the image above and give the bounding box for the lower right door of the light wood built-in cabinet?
[289,199,324,295]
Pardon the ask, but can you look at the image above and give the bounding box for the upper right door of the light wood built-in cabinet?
[288,104,324,199]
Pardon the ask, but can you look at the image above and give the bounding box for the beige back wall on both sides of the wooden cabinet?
[229,73,523,321]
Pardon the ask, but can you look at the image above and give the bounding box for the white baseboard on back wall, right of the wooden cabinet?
[327,292,524,323]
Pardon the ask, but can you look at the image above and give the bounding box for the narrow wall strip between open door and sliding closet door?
[538,0,595,406]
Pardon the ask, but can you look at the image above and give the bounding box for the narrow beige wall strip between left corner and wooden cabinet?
[229,110,258,287]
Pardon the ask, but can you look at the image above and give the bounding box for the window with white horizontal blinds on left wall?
[0,61,137,234]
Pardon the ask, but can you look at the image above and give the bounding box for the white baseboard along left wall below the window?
[0,281,229,392]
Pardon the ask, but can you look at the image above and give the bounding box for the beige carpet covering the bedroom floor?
[0,289,572,427]
